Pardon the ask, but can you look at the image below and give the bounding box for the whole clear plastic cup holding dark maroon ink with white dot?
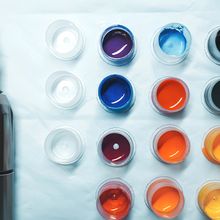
[98,128,135,167]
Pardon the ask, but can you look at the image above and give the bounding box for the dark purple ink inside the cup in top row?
[102,29,133,58]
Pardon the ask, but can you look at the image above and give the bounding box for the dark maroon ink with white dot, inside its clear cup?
[101,133,131,164]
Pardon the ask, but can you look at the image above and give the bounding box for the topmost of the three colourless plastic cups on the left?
[46,20,84,60]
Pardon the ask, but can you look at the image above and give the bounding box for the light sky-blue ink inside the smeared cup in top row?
[159,28,187,56]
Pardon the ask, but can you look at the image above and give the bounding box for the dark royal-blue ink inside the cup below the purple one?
[101,78,132,108]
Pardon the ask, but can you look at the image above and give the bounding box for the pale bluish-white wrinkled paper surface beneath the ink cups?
[0,0,220,220]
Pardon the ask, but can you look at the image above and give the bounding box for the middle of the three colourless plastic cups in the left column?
[46,71,85,109]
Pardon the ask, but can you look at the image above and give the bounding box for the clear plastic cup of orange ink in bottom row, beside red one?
[145,177,184,219]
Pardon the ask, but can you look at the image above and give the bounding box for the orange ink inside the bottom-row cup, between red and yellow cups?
[152,186,180,217]
